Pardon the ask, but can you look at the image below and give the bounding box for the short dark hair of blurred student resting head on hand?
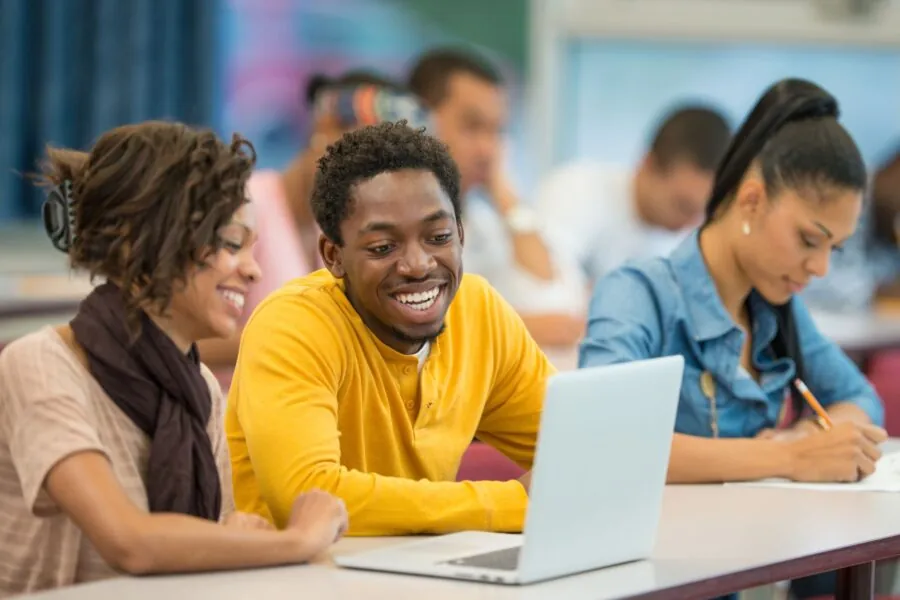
[407,48,503,108]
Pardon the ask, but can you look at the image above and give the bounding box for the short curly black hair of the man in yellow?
[311,121,461,246]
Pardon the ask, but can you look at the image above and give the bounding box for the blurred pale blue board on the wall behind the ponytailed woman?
[556,39,900,171]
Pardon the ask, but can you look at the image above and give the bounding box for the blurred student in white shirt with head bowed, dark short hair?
[536,106,731,282]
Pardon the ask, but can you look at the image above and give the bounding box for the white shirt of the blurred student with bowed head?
[535,163,688,281]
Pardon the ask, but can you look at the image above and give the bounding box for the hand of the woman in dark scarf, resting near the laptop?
[285,490,348,557]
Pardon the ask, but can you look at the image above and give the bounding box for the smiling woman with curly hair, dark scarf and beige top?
[0,122,347,596]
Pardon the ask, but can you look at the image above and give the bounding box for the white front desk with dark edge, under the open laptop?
[22,464,900,600]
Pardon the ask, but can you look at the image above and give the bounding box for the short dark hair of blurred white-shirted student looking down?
[650,106,731,171]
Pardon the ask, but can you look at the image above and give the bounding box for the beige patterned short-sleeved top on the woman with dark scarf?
[0,327,234,598]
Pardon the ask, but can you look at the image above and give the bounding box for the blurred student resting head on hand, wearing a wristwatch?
[409,48,587,346]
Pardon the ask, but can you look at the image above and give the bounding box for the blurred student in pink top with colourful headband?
[199,70,426,390]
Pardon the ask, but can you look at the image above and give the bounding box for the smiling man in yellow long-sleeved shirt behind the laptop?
[226,122,554,535]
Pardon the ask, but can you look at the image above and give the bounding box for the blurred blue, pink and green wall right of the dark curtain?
[220,0,528,178]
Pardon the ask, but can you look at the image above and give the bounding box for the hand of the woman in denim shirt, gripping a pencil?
[785,421,887,482]
